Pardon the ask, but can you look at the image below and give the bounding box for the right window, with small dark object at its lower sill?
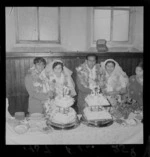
[93,7,130,43]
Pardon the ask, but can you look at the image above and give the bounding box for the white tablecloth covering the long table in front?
[6,119,143,145]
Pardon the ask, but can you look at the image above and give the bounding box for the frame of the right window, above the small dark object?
[91,7,135,45]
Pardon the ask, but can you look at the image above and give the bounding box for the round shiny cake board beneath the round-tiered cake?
[47,119,79,130]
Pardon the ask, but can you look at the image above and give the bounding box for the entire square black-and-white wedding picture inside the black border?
[5,6,144,147]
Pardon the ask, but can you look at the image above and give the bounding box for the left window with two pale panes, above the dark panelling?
[16,7,60,43]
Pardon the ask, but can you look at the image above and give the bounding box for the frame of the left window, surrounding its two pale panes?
[14,7,61,44]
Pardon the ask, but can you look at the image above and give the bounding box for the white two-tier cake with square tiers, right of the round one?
[83,91,112,121]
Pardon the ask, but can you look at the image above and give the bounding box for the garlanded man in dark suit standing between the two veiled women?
[76,54,103,114]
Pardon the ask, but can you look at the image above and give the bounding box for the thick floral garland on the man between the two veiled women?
[76,63,103,88]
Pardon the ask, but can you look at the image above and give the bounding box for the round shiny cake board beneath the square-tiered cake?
[81,116,113,127]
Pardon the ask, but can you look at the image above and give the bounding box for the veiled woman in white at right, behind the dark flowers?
[101,59,128,99]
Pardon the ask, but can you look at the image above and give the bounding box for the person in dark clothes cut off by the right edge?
[128,62,143,110]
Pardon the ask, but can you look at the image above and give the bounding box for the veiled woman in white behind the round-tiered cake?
[45,60,76,97]
